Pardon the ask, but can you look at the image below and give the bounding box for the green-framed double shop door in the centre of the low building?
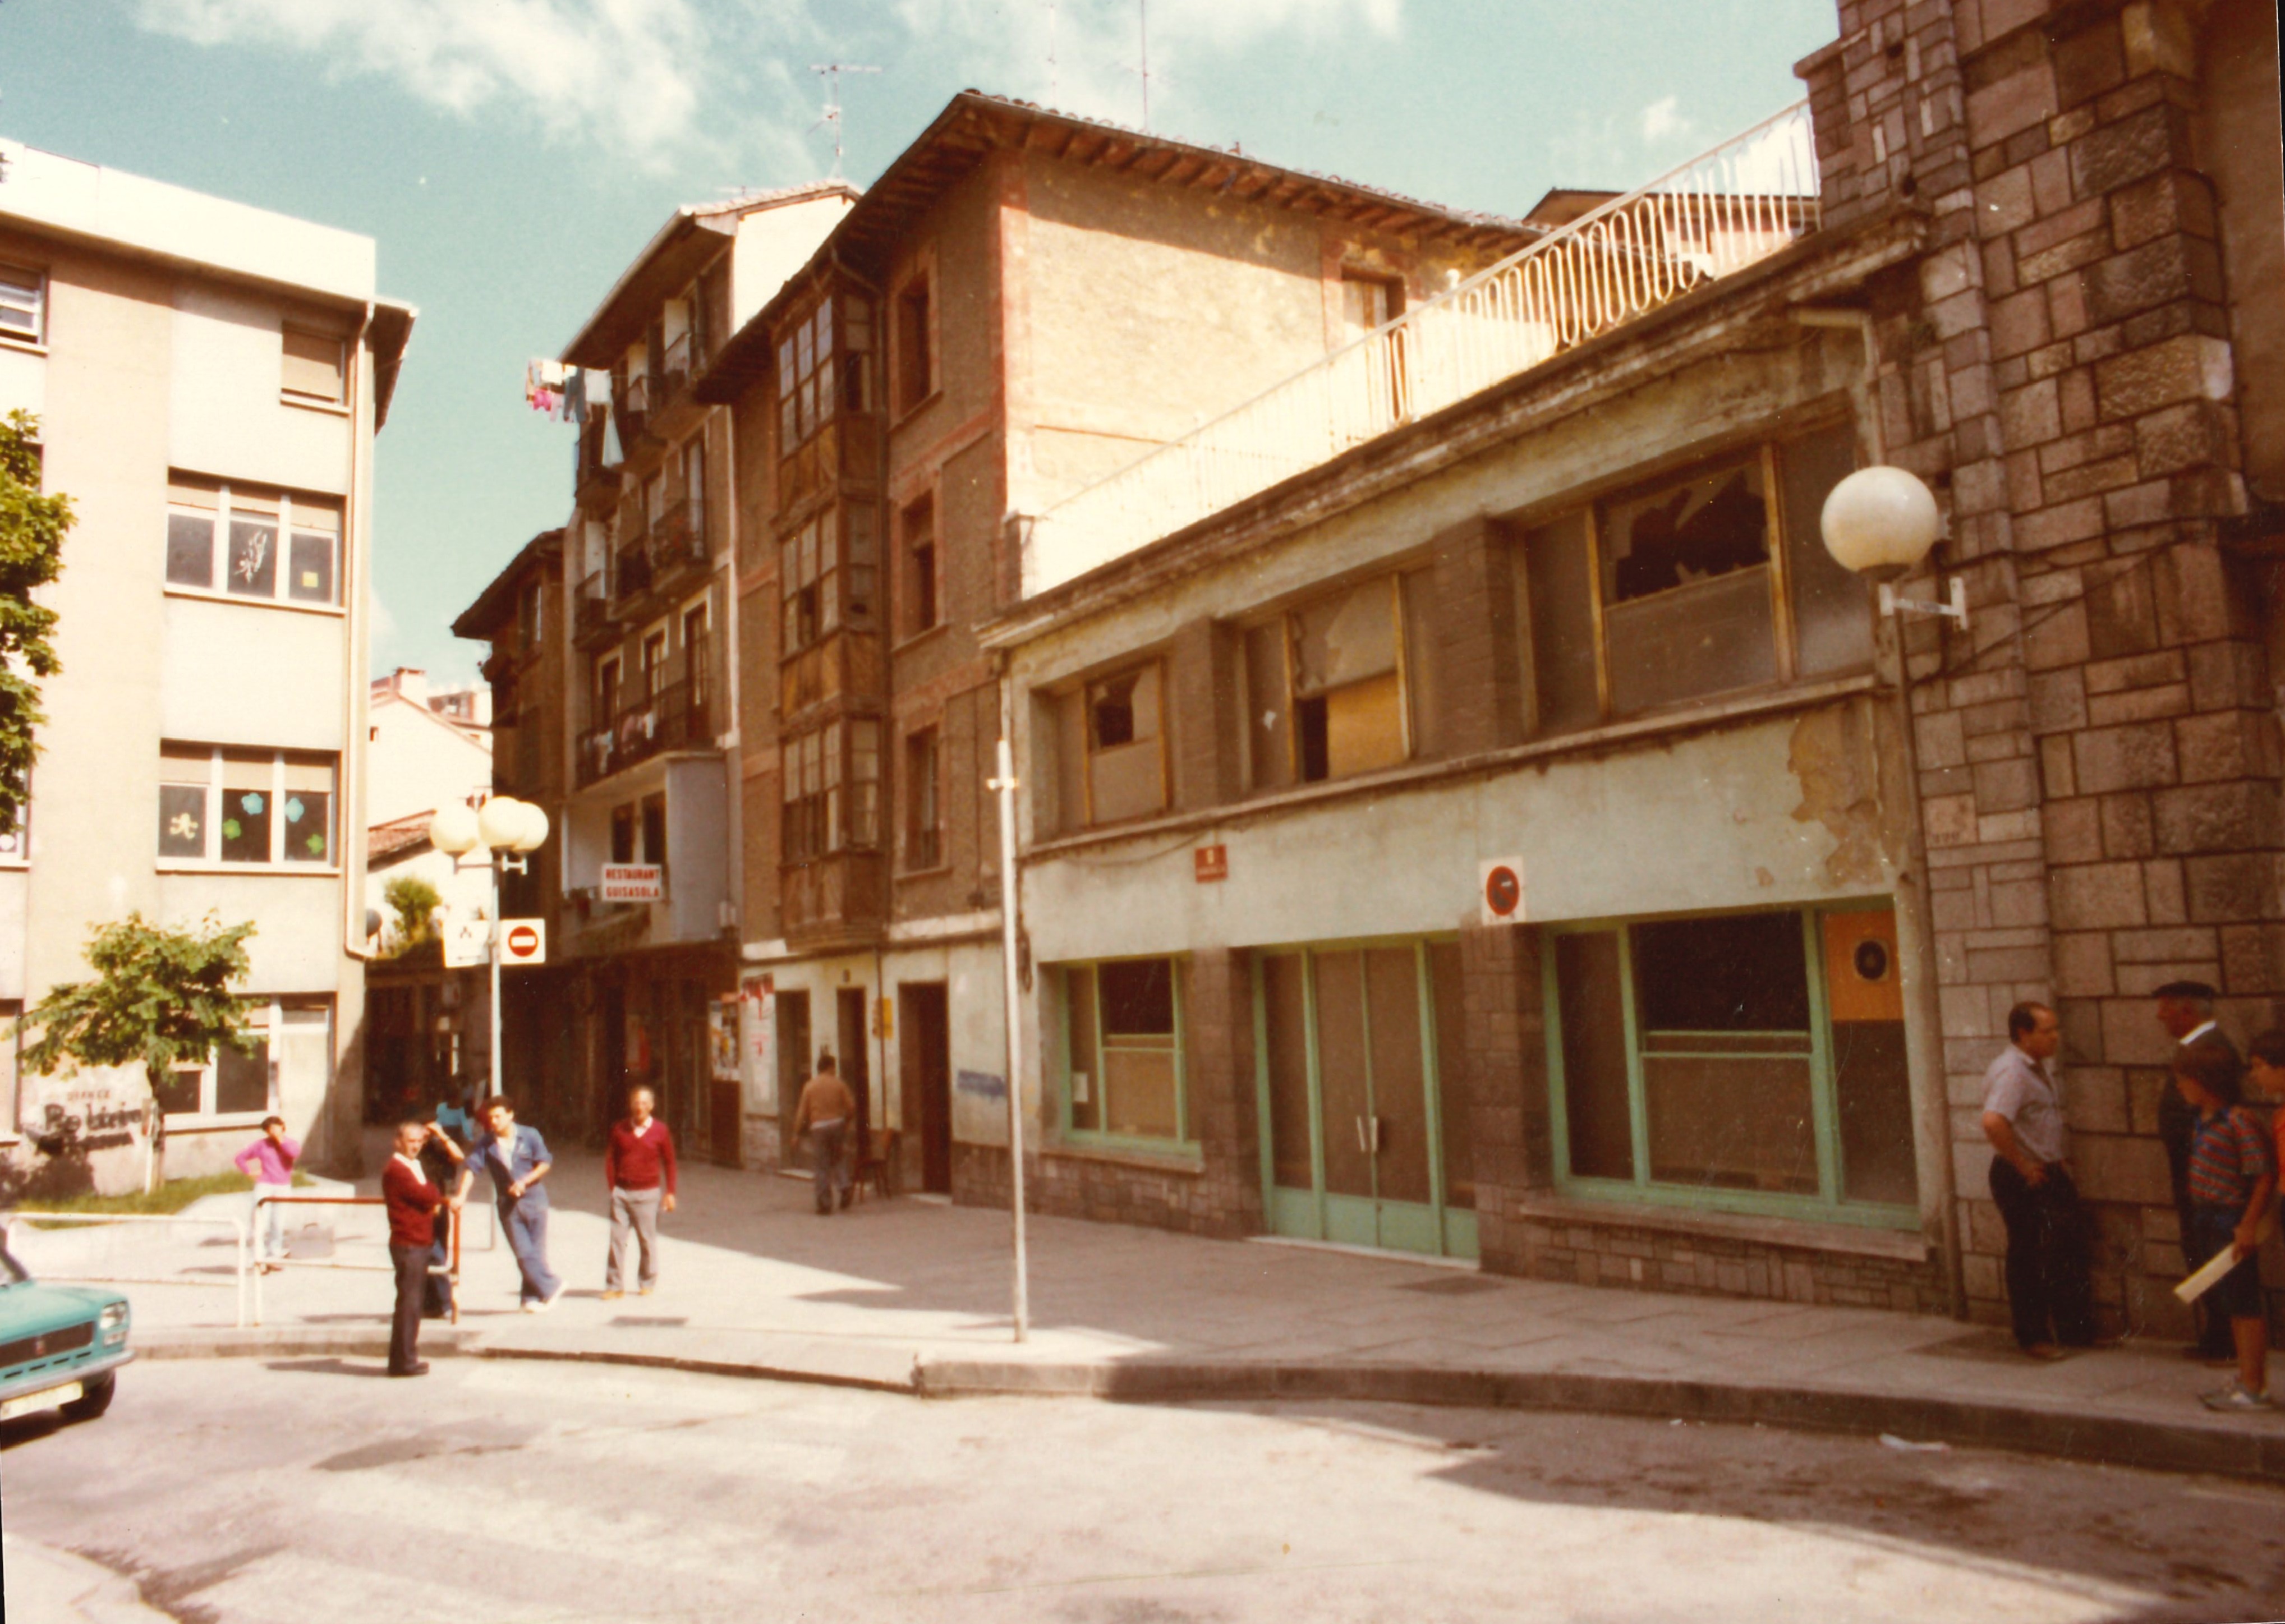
[1254,941,1476,1256]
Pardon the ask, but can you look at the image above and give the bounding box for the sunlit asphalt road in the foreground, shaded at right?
[0,1359,2285,1624]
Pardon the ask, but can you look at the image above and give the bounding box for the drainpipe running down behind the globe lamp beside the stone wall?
[1791,306,1967,1320]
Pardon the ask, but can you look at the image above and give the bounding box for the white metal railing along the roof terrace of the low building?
[1024,103,1817,594]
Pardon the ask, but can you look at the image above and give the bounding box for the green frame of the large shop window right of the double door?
[1540,898,1921,1229]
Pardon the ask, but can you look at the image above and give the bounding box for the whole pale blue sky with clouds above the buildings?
[0,0,1837,674]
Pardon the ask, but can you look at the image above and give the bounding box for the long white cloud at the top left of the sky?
[139,0,731,162]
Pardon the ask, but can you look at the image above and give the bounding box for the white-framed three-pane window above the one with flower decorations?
[167,475,341,605]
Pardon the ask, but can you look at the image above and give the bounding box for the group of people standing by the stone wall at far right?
[1983,980,2285,1411]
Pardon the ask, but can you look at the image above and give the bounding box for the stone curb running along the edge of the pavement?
[135,1327,2285,1483]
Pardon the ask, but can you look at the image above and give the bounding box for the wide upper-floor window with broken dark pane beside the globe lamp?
[1515,425,1872,733]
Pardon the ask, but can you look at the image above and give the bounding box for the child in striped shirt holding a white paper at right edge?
[2173,1044,2276,1409]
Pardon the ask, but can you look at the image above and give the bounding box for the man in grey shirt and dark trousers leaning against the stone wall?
[1983,1002,2095,1359]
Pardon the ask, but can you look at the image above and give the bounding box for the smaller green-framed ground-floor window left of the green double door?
[1056,955,1197,1151]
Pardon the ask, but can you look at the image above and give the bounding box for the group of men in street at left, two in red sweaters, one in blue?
[381,1087,677,1375]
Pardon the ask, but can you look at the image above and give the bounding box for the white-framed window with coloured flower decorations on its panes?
[158,742,336,866]
